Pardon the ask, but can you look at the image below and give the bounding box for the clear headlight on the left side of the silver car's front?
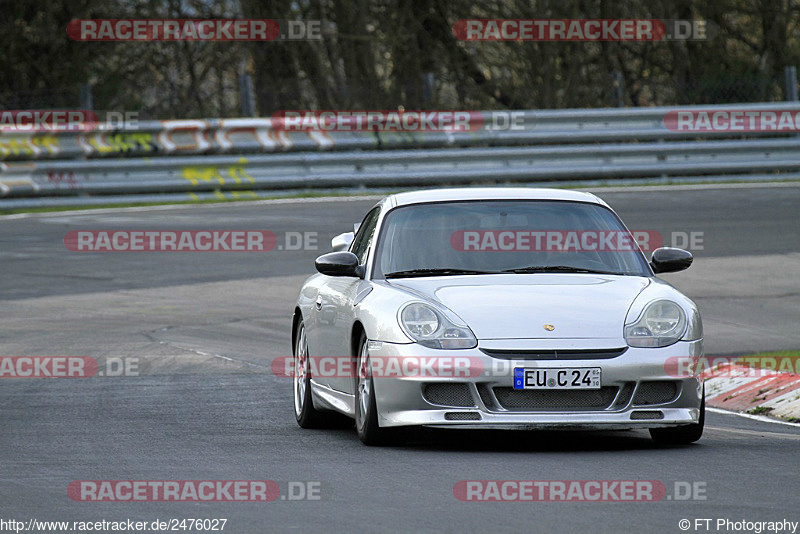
[398,302,478,349]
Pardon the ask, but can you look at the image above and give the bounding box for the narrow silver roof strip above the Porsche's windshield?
[386,187,608,207]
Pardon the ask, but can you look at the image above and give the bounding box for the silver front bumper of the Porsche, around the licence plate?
[369,340,703,430]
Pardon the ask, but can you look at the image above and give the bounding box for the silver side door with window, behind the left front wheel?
[311,207,380,393]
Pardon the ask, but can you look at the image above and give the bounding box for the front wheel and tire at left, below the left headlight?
[355,332,397,445]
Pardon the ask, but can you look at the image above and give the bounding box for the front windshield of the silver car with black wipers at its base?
[373,200,650,278]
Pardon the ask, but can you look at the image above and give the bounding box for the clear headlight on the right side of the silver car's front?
[625,300,686,347]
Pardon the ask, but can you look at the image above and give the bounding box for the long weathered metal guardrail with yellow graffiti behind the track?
[0,102,800,206]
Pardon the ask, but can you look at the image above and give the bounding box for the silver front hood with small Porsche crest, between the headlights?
[391,273,650,340]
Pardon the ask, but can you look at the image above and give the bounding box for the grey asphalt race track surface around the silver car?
[0,184,800,533]
